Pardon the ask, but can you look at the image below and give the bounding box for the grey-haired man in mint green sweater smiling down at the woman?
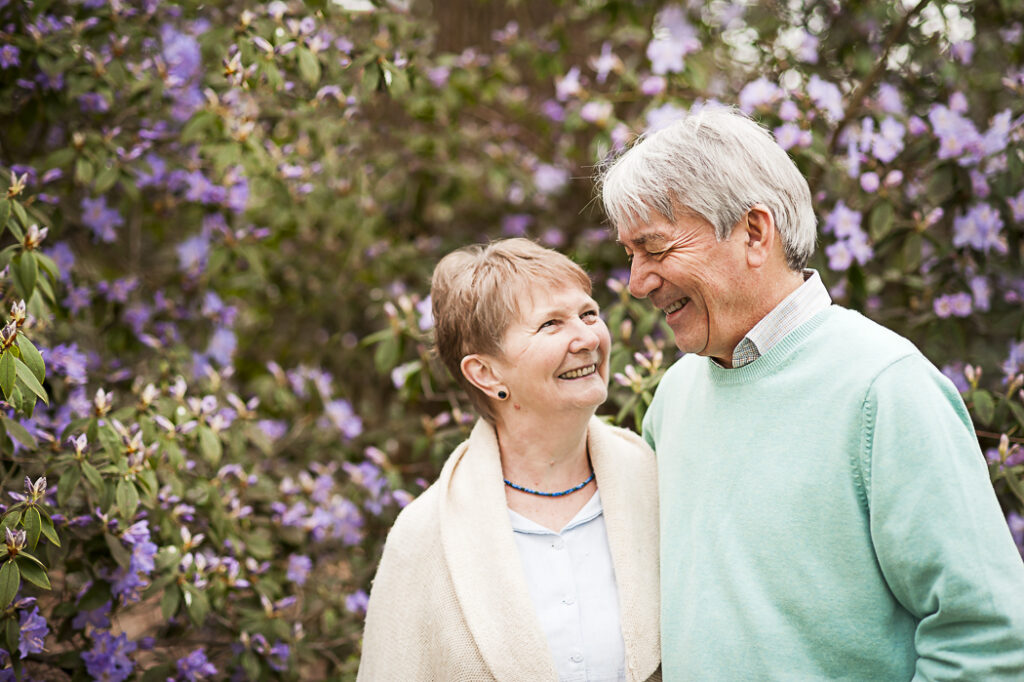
[601,103,1024,682]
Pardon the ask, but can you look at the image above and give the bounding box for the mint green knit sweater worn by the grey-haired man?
[644,306,1024,682]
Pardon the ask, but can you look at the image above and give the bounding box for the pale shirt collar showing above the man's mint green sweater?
[732,269,831,369]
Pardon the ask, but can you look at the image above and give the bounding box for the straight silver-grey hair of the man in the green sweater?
[598,106,817,270]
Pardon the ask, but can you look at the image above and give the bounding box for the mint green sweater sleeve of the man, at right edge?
[862,354,1024,682]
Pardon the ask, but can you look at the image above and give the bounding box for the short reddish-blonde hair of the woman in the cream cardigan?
[430,239,591,423]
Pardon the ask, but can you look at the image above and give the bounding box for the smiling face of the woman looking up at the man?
[495,286,611,414]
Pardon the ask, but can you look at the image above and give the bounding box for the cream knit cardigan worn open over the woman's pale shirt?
[358,418,662,682]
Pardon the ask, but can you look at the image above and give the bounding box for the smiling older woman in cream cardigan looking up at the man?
[359,239,660,682]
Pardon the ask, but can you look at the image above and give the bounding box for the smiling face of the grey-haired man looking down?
[618,213,758,367]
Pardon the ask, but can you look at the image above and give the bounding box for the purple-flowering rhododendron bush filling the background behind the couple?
[0,0,1024,680]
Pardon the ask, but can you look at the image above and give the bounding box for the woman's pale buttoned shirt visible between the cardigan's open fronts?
[509,491,626,682]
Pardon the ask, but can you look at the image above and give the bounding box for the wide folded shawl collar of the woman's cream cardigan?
[437,418,660,682]
